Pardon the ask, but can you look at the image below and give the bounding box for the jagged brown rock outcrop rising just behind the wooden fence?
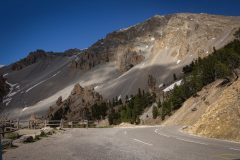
[48,84,102,120]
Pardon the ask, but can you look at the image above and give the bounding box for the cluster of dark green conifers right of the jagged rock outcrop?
[91,88,155,125]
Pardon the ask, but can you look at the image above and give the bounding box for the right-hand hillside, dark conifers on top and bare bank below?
[161,29,240,141]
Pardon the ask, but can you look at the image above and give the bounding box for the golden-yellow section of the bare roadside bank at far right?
[188,80,240,142]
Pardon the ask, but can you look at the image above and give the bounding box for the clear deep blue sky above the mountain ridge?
[0,0,240,64]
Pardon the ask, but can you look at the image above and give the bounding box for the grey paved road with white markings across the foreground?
[4,126,240,160]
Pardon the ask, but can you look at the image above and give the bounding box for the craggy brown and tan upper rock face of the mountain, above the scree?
[72,14,240,72]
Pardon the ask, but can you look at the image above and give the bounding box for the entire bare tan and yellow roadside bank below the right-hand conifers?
[164,77,240,141]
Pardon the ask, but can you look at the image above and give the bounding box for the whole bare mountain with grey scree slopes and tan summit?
[0,13,240,117]
